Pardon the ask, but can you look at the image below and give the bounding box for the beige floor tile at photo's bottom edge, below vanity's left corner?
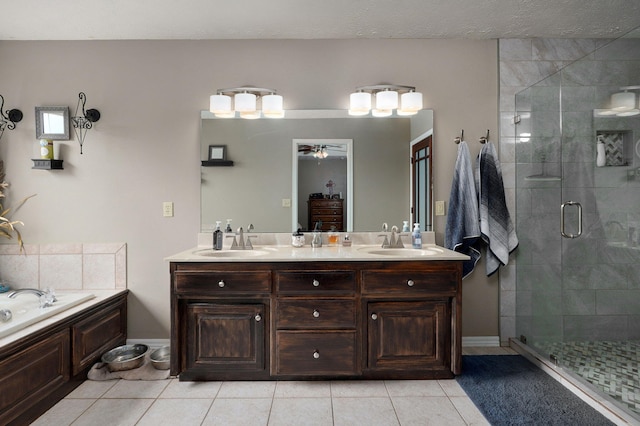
[136,399,213,426]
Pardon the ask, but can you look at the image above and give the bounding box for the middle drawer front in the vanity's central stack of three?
[276,299,356,329]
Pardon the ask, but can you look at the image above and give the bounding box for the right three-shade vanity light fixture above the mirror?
[349,84,422,117]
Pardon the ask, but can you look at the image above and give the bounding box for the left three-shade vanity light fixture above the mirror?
[209,87,284,119]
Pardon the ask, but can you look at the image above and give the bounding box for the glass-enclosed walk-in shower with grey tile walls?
[514,25,640,419]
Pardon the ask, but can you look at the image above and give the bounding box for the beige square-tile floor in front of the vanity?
[33,348,514,426]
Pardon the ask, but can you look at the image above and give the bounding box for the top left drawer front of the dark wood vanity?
[173,271,271,296]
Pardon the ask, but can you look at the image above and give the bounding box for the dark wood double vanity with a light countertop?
[168,238,467,380]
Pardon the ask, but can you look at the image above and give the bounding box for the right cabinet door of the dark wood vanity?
[367,300,452,377]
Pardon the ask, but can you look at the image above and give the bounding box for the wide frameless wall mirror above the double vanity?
[200,110,433,232]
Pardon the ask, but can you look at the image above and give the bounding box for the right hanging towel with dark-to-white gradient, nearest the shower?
[475,142,518,276]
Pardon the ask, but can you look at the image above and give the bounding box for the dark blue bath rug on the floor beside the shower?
[456,355,613,426]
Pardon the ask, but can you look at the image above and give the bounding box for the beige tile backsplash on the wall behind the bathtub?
[0,243,127,290]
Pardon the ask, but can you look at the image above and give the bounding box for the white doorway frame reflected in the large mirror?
[291,139,353,232]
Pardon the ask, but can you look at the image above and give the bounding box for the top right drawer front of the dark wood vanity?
[362,269,457,295]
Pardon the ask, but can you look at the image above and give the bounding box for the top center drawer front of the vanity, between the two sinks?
[276,271,356,294]
